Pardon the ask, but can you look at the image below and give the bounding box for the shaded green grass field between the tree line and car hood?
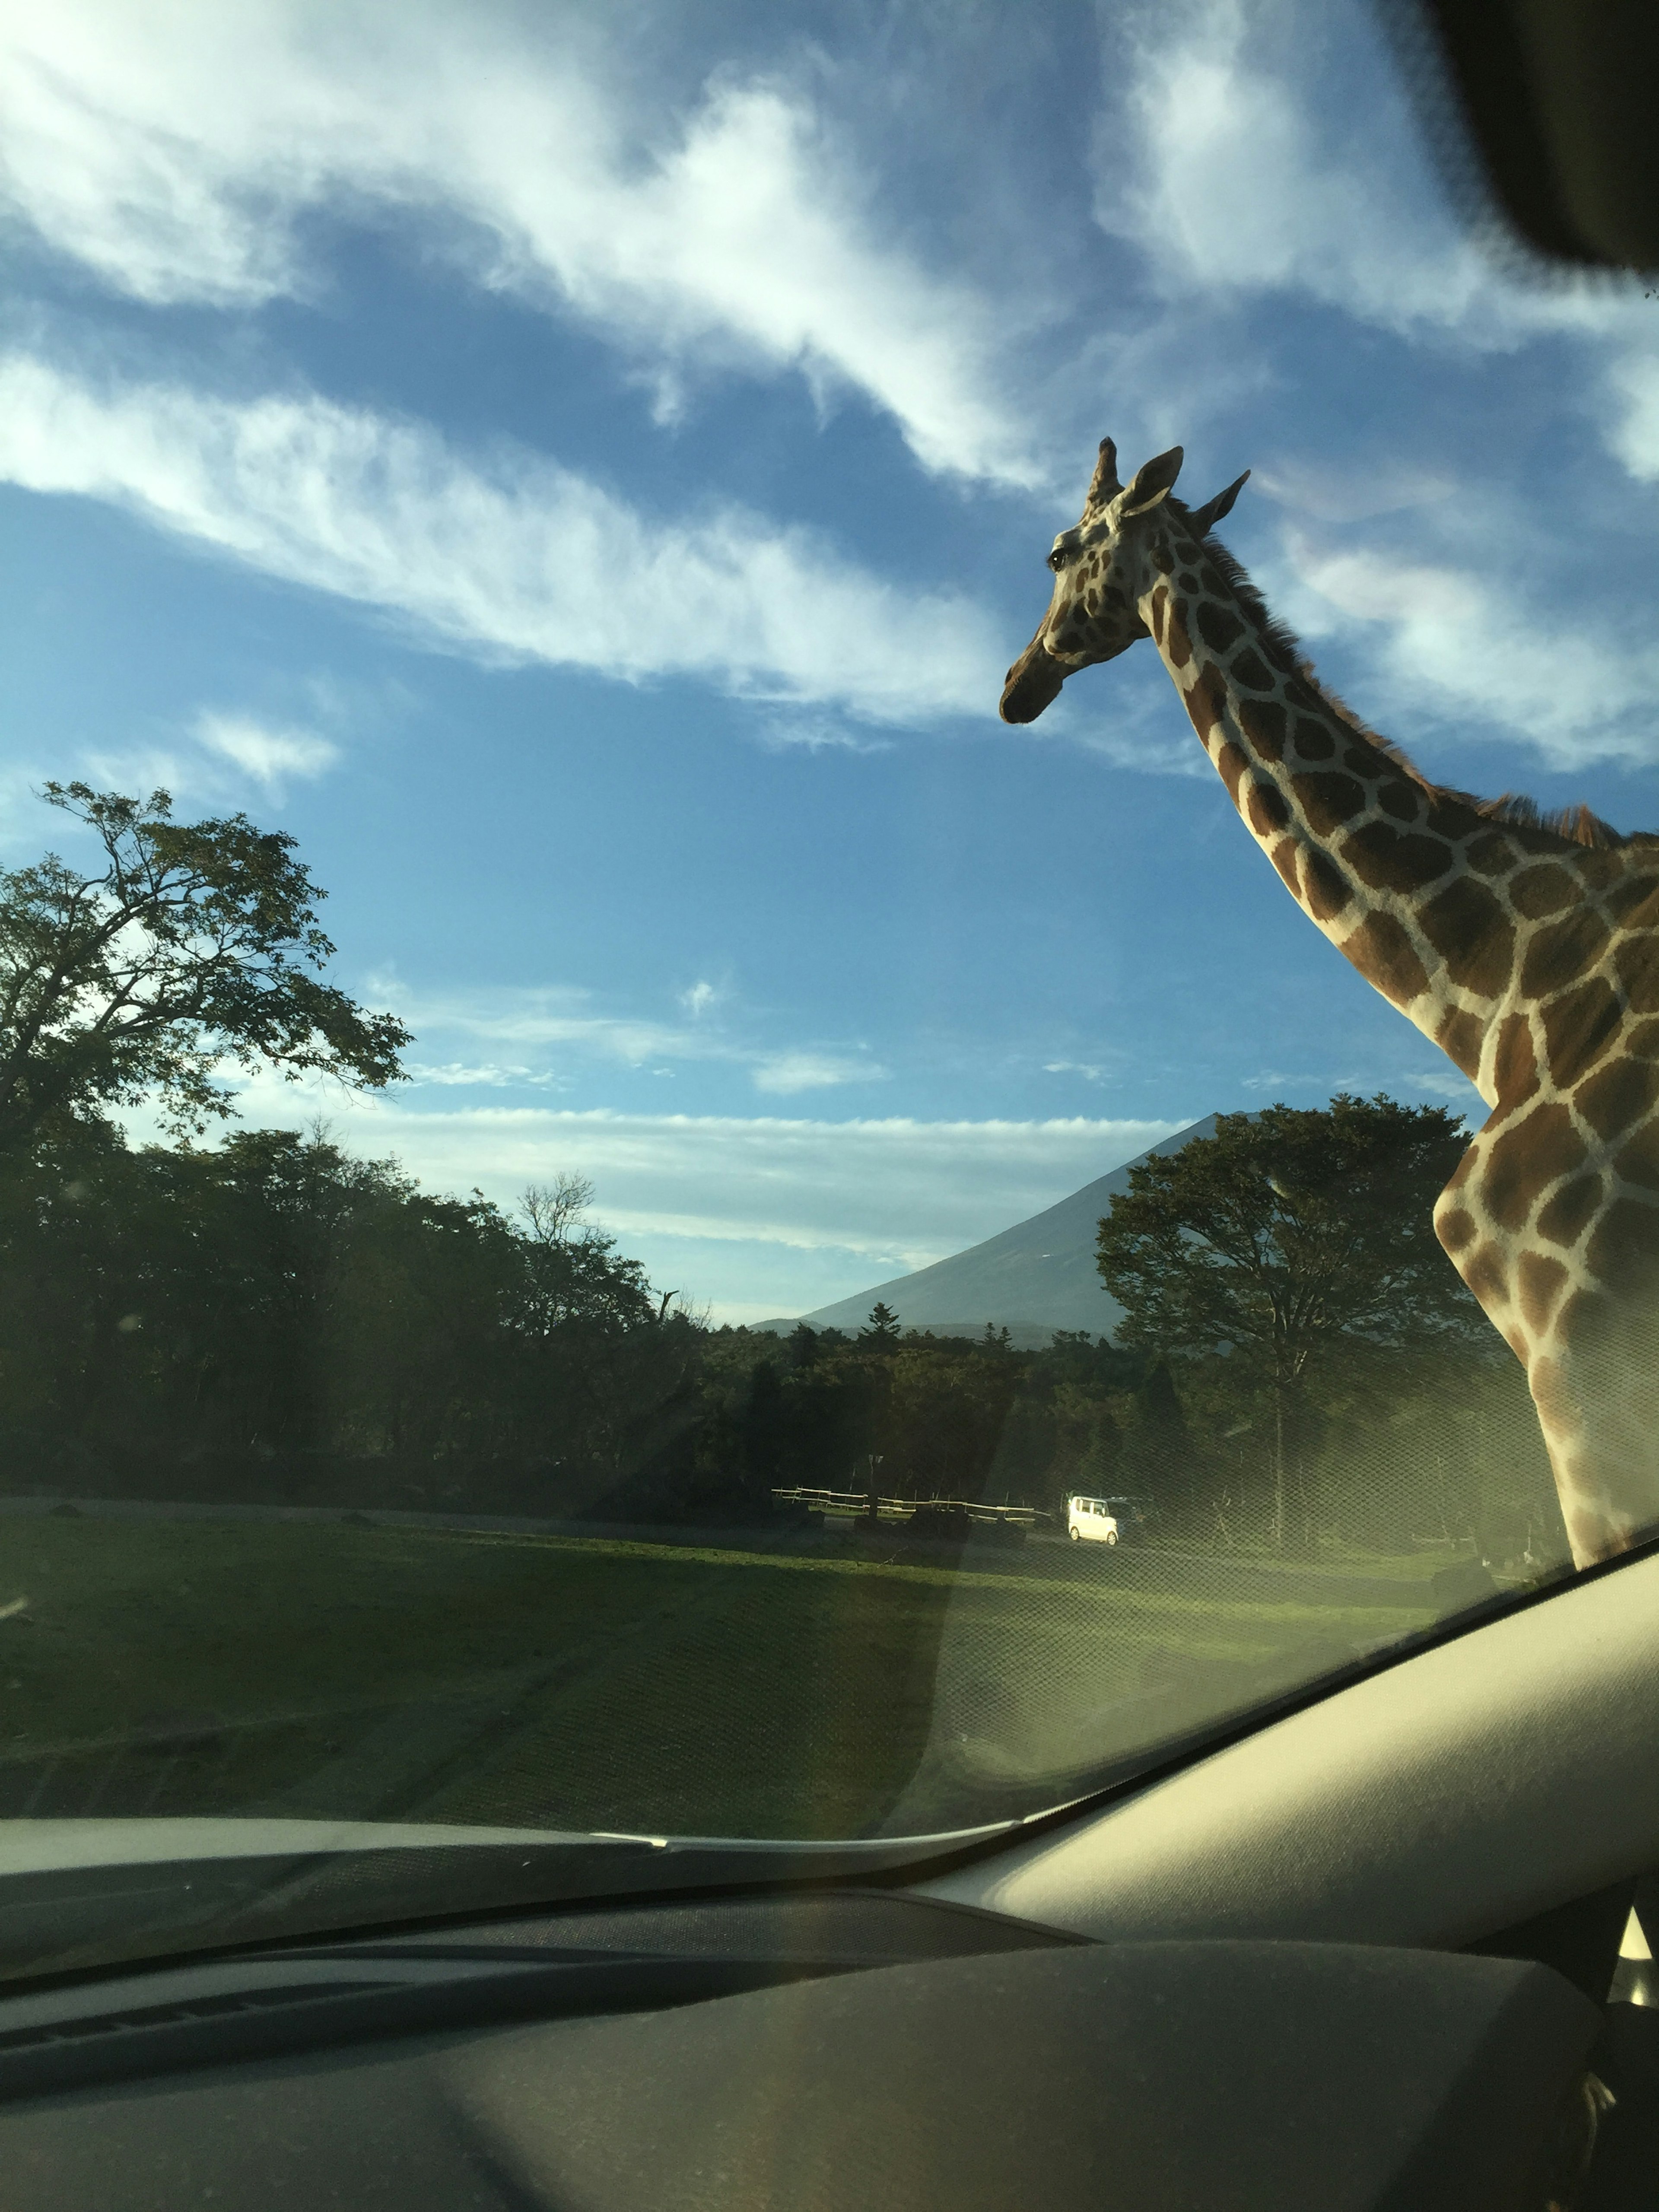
[0,1517,1442,1836]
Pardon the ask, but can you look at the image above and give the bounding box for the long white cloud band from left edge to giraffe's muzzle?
[0,352,1007,721]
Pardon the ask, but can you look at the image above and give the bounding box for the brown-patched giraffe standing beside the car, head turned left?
[1002,438,1659,1566]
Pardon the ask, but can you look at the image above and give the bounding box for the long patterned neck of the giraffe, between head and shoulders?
[1139,537,1557,1104]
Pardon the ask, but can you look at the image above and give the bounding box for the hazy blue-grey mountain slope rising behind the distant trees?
[761,1115,1214,1349]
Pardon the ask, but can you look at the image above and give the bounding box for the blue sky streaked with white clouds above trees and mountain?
[0,0,1659,1319]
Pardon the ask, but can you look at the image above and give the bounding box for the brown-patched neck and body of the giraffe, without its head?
[1095,498,1659,1557]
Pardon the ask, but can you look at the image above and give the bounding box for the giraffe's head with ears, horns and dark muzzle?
[1002,438,1250,721]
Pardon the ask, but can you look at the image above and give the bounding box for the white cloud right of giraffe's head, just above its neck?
[1285,531,1659,768]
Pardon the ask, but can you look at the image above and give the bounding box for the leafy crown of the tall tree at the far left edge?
[0,783,409,1153]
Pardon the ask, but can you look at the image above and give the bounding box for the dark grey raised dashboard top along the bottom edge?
[0,1944,1602,2212]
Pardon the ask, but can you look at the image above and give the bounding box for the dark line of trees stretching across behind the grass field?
[0,783,1553,1551]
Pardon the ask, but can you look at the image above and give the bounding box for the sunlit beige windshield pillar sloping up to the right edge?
[914,1553,1659,1949]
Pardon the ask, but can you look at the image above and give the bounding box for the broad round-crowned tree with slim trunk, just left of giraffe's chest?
[1097,1095,1484,1546]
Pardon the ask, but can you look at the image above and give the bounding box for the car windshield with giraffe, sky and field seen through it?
[0,0,1659,1975]
